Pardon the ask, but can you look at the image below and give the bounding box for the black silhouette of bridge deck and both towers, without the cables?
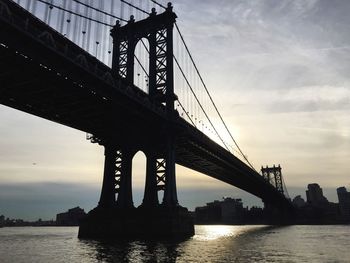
[0,0,291,236]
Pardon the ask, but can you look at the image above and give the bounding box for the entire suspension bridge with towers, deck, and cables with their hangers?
[0,0,292,237]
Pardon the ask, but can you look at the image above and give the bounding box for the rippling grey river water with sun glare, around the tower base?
[0,225,350,263]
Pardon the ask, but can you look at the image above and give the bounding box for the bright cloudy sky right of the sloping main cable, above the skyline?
[174,0,350,194]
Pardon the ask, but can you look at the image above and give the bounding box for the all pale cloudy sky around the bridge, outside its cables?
[0,0,350,220]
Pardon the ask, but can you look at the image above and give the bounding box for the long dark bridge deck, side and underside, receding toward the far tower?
[0,0,291,229]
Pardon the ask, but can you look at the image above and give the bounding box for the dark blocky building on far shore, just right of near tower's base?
[195,198,244,224]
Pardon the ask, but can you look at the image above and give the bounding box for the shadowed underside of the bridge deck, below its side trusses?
[0,39,290,211]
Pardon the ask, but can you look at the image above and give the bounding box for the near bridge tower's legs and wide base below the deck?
[79,143,194,238]
